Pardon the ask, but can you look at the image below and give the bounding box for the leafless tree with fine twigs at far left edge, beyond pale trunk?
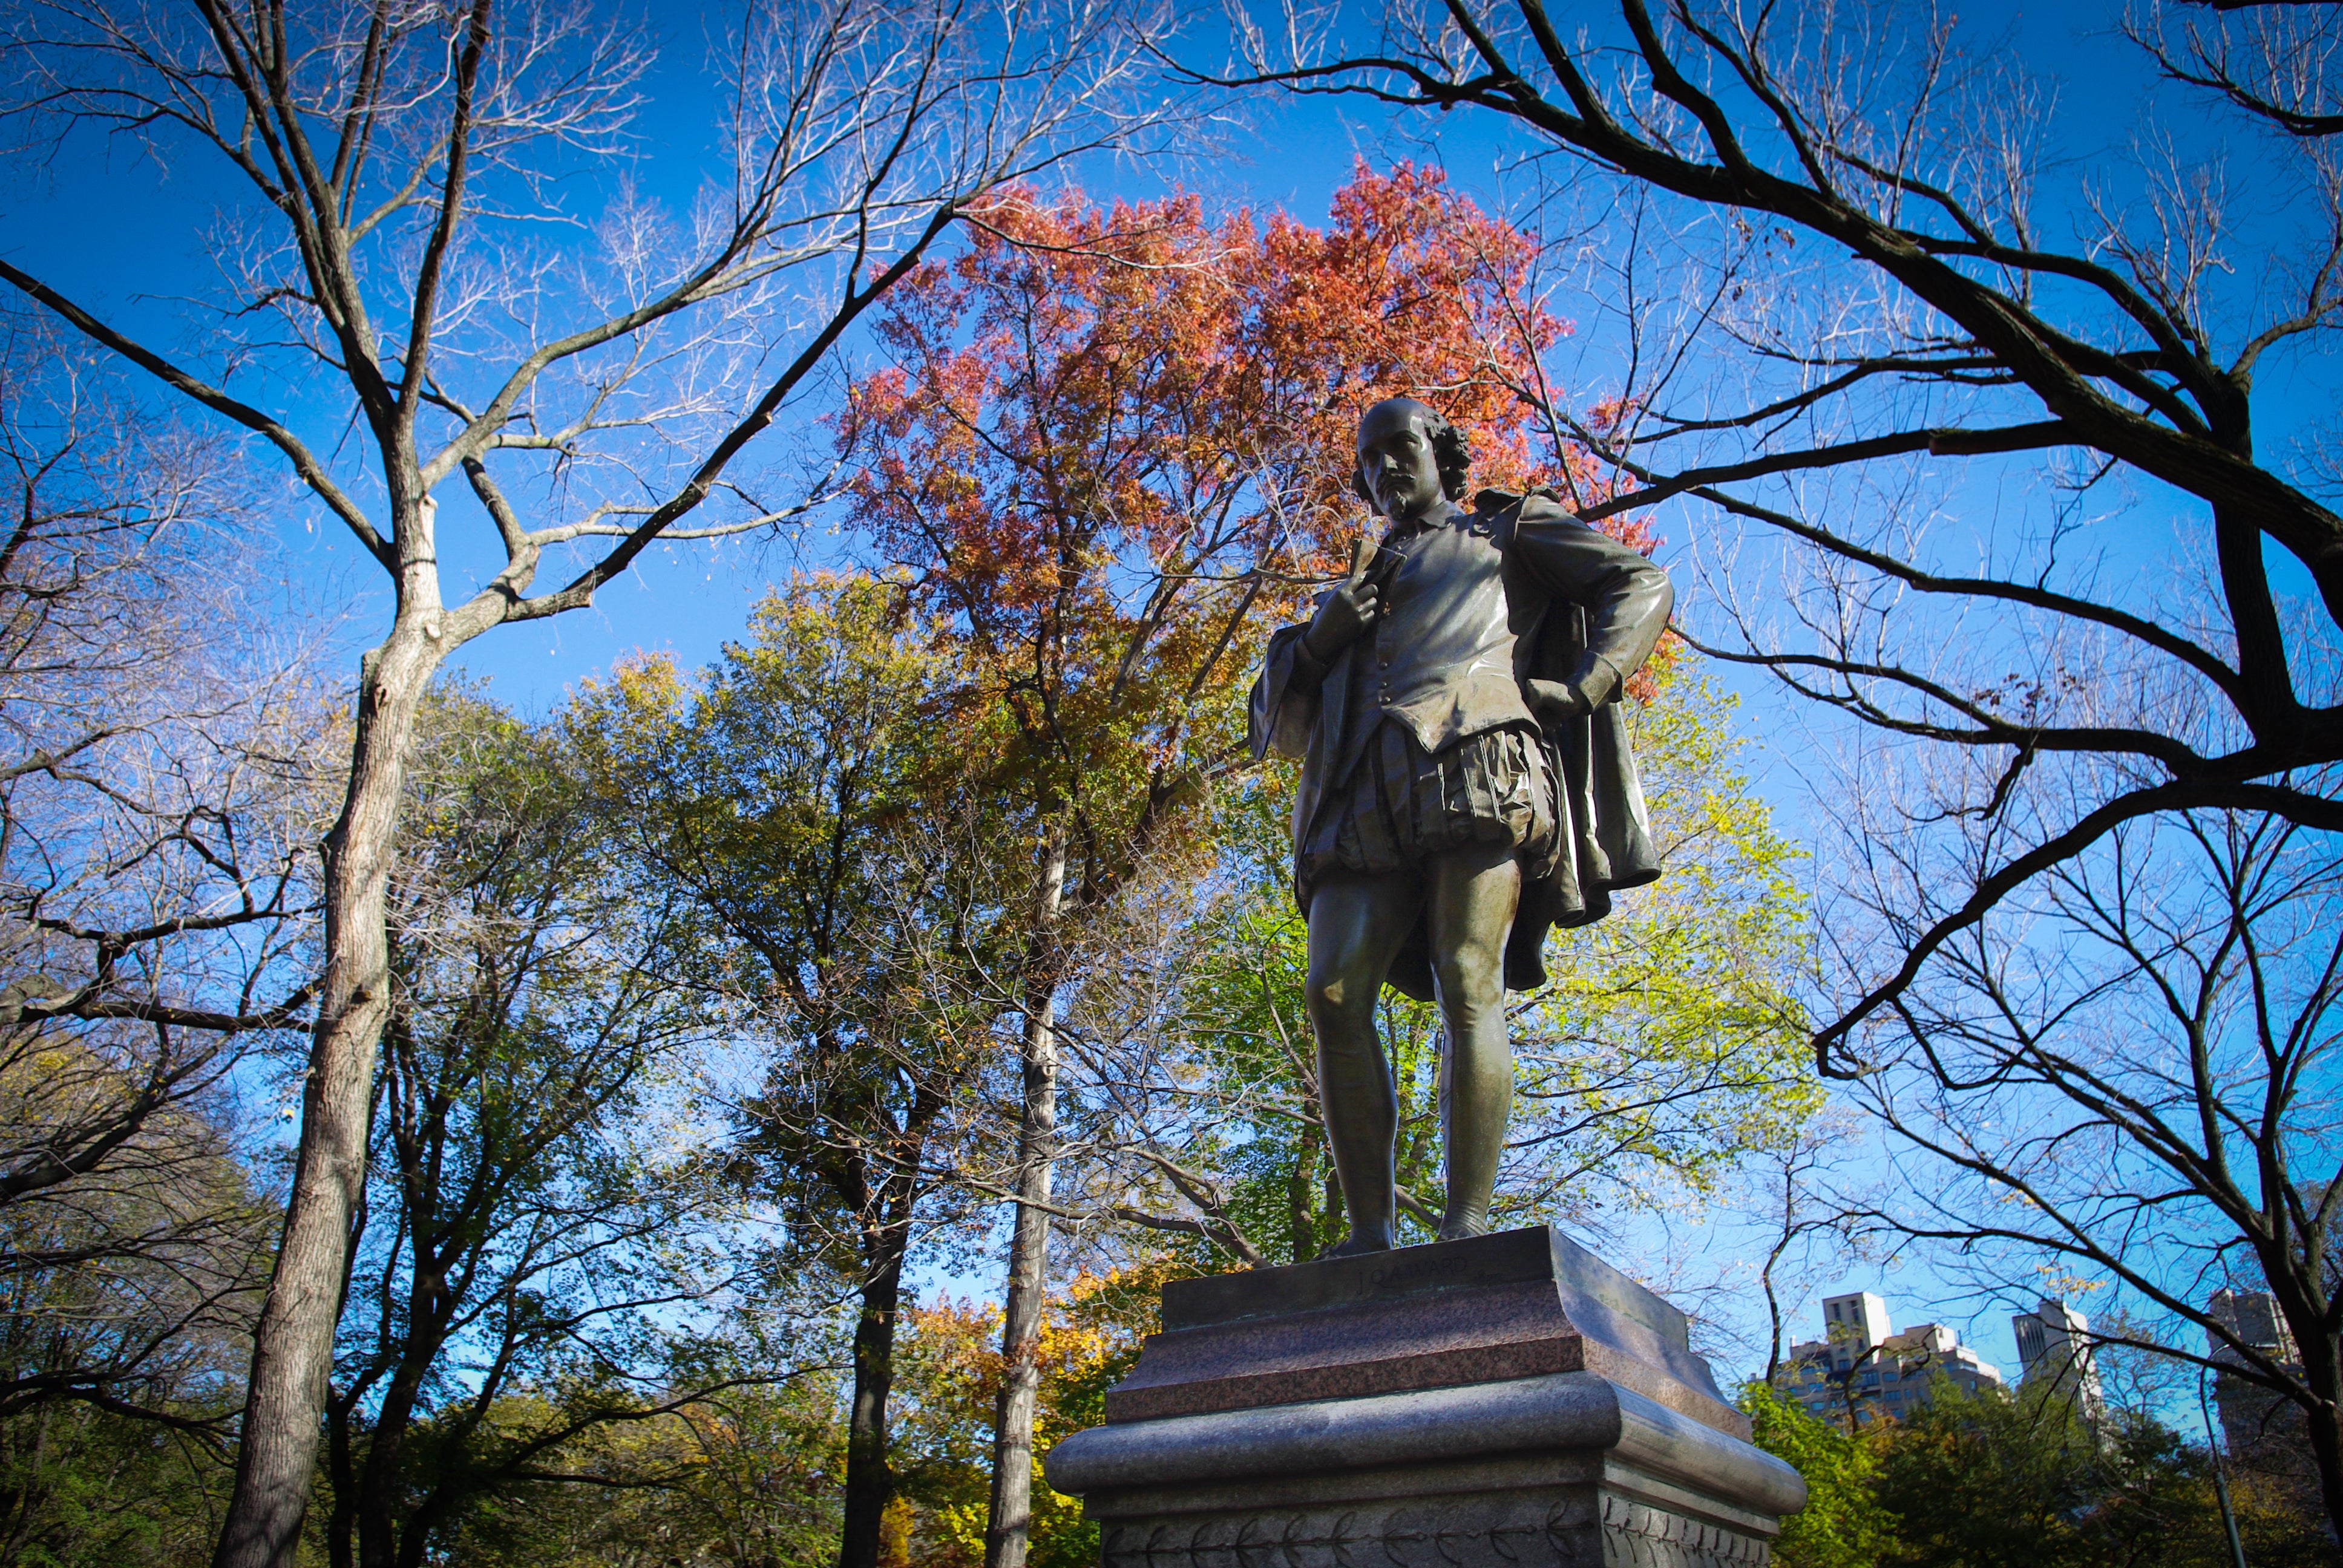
[0,312,328,1434]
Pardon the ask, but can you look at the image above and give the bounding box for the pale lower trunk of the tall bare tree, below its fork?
[211,623,443,1568]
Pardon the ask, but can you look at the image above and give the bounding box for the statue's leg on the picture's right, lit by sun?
[1424,844,1521,1242]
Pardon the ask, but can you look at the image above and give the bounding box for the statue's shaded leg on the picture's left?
[1303,872,1424,1256]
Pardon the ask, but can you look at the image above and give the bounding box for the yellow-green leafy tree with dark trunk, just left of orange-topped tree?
[565,577,1019,1568]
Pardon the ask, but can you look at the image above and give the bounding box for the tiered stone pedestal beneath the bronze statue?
[1045,1228,1806,1568]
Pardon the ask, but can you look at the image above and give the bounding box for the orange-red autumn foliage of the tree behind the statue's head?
[839,162,1636,862]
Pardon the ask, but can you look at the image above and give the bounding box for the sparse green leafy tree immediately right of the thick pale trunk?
[326,689,759,1568]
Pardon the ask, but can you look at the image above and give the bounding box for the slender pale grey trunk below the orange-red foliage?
[984,834,1066,1568]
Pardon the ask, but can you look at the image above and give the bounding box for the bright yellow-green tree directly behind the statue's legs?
[1119,654,1821,1261]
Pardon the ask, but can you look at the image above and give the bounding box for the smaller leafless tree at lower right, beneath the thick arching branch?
[1837,788,2343,1500]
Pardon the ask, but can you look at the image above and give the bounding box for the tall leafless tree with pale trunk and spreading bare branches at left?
[0,0,1172,1568]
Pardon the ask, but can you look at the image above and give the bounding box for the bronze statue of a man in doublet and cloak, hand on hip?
[1251,399,1675,1256]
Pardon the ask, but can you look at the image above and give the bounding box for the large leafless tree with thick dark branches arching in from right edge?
[1195,0,2343,1519]
